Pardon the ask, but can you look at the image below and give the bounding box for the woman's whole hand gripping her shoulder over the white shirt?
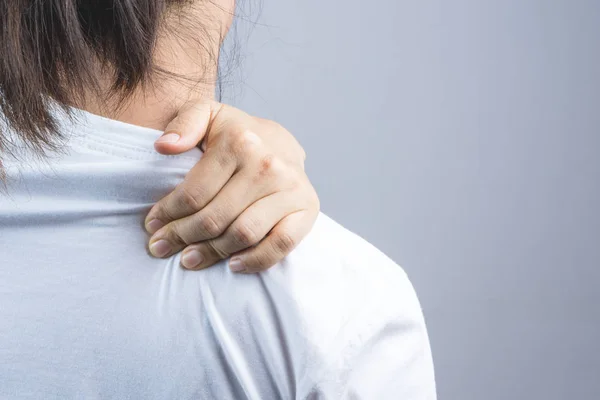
[145,101,319,273]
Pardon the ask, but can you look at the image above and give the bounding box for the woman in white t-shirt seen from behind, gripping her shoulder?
[0,0,435,399]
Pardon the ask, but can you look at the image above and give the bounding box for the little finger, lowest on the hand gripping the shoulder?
[229,209,318,273]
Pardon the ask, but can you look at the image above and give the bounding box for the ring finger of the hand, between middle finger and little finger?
[181,191,303,270]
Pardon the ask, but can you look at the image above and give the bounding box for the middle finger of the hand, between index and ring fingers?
[150,156,292,257]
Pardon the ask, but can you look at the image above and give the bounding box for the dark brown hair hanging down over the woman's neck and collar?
[0,0,212,175]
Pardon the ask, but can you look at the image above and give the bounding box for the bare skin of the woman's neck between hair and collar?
[81,0,234,130]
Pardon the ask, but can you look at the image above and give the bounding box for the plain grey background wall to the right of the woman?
[225,0,600,400]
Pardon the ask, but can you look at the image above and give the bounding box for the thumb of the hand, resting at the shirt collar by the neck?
[154,100,221,155]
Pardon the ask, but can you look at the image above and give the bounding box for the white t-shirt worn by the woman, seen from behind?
[0,108,436,400]
